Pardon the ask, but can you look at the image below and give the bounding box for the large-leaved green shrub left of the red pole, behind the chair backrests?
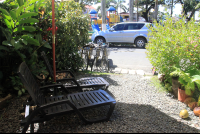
[0,0,51,95]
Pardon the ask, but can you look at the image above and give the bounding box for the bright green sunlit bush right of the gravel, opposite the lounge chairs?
[146,18,200,81]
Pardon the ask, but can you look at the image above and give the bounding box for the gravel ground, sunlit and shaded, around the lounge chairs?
[0,74,200,133]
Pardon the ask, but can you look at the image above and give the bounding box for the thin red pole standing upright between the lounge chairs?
[52,0,56,82]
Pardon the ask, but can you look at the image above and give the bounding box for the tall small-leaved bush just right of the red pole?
[49,0,90,71]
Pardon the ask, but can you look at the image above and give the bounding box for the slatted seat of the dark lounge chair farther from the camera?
[64,77,109,88]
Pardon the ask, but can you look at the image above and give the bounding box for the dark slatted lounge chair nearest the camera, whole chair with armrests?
[18,62,116,133]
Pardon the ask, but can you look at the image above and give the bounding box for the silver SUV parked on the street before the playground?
[91,22,152,48]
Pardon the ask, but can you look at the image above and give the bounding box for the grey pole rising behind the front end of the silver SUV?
[101,0,106,30]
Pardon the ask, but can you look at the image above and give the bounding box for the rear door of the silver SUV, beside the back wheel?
[123,23,144,43]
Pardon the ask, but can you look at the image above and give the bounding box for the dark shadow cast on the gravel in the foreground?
[38,100,198,133]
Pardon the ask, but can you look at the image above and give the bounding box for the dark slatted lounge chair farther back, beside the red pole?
[41,51,109,90]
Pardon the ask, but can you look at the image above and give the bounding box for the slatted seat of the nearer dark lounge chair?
[45,89,116,115]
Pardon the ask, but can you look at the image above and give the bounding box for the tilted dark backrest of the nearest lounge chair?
[17,62,45,106]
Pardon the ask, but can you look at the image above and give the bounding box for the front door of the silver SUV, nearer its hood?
[105,24,124,42]
